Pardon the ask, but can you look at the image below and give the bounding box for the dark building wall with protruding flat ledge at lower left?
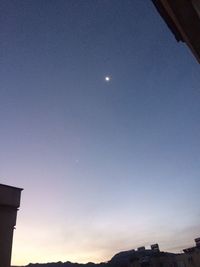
[0,184,22,267]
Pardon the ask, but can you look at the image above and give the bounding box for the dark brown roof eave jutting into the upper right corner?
[152,0,200,63]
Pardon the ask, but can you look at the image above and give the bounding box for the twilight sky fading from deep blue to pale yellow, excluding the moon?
[0,0,200,265]
